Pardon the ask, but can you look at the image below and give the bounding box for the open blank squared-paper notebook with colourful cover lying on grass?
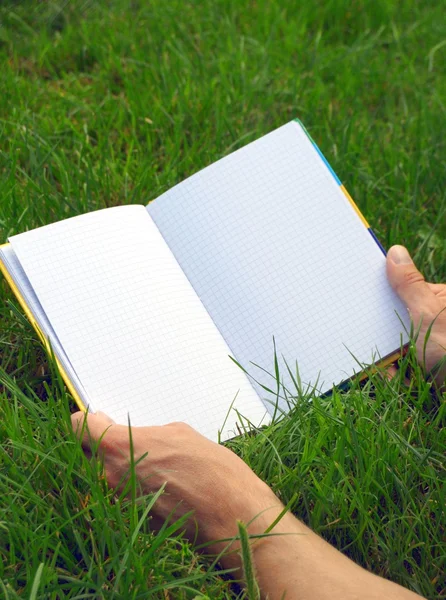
[0,121,409,439]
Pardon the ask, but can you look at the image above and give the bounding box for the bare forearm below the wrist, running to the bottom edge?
[214,492,420,600]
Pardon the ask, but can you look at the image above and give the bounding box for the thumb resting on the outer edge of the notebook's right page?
[387,246,433,312]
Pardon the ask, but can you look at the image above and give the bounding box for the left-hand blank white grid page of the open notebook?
[10,206,265,439]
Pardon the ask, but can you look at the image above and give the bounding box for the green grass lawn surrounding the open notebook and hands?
[0,0,446,599]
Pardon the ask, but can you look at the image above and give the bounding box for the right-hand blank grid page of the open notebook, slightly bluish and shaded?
[147,122,408,412]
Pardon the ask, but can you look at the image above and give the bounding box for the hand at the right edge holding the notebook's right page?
[387,246,446,385]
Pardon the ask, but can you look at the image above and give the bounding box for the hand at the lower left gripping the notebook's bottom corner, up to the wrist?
[71,412,283,568]
